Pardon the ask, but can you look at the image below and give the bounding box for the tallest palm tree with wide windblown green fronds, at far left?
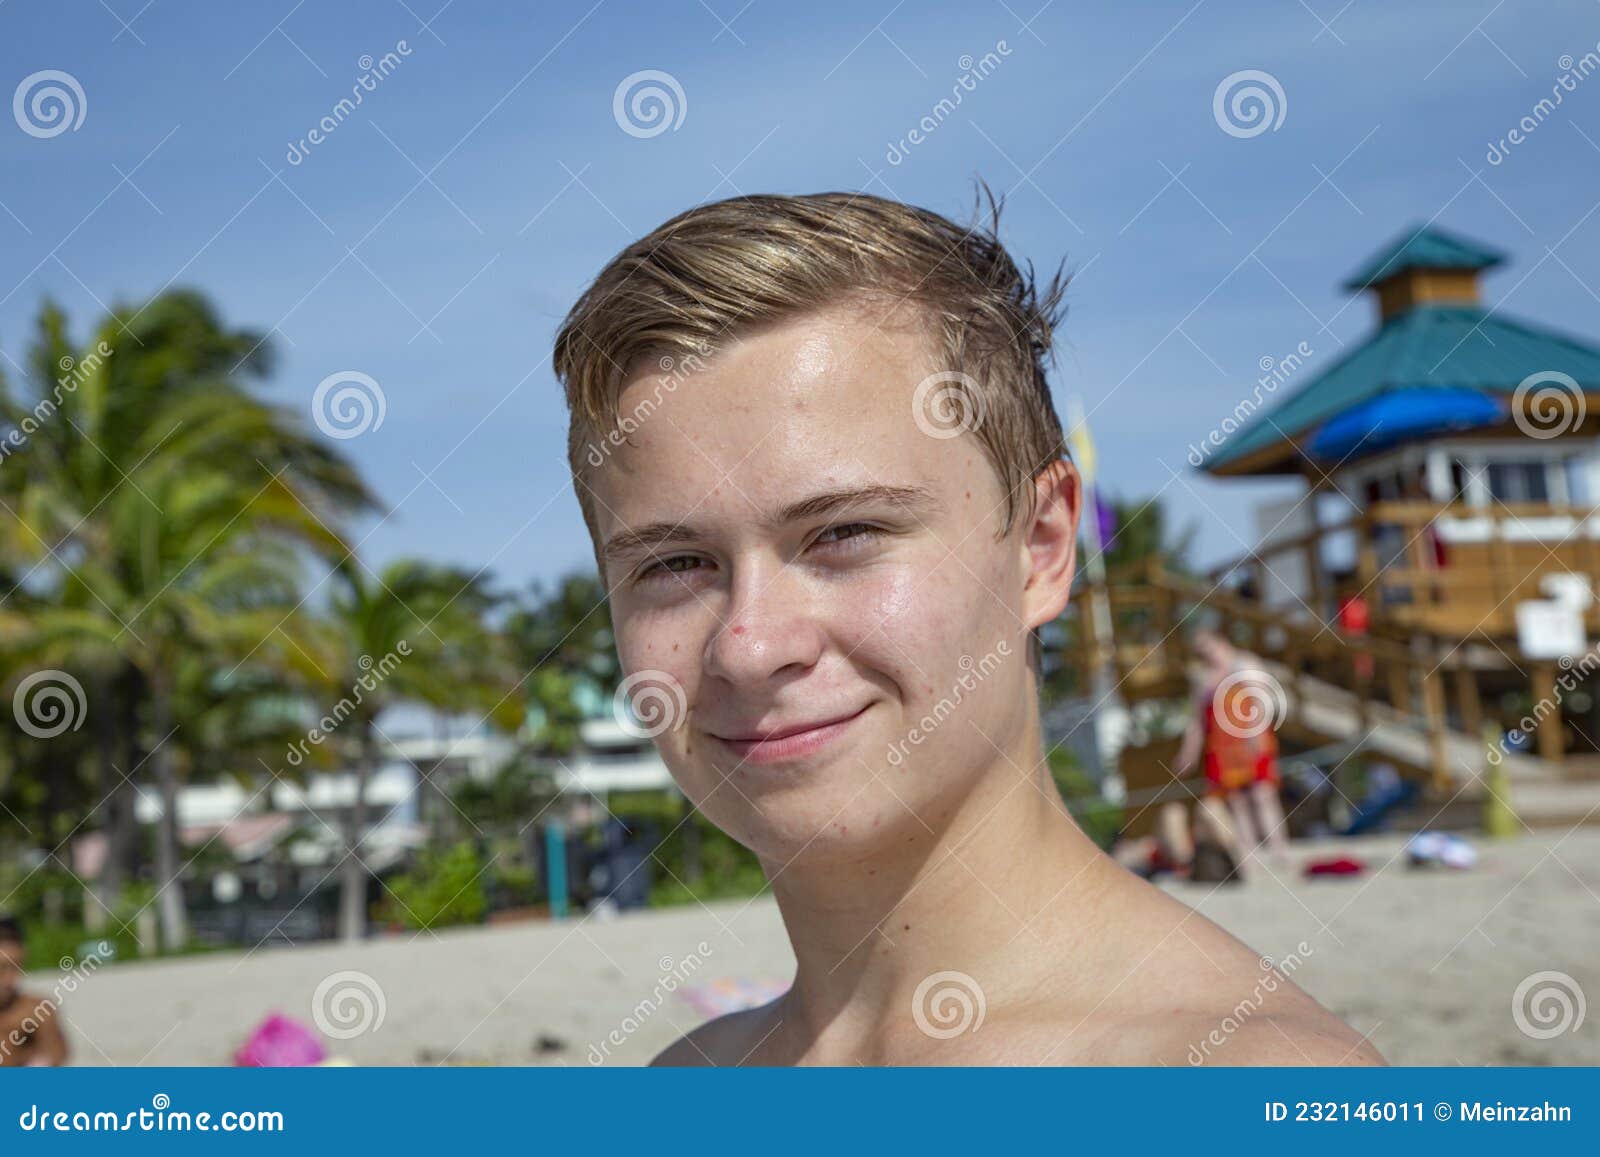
[0,291,376,949]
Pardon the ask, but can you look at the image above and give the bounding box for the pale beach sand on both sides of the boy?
[43,827,1600,1066]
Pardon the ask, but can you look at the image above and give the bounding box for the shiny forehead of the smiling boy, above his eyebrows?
[590,310,981,528]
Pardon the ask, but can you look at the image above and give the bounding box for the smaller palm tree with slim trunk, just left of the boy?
[325,560,523,939]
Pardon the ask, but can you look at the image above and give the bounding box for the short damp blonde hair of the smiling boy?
[554,186,1067,538]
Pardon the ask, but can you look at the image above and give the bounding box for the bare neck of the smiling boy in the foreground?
[755,739,1104,1063]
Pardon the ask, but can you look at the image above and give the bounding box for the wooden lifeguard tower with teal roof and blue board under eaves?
[1072,226,1600,821]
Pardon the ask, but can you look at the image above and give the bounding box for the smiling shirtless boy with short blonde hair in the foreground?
[554,192,1381,1066]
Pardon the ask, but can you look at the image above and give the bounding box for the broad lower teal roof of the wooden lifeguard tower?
[1203,306,1600,474]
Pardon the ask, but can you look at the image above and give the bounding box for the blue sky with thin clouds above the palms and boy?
[0,0,1600,584]
